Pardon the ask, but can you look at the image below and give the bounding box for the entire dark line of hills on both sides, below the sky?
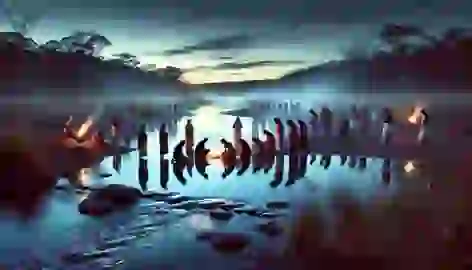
[0,24,472,97]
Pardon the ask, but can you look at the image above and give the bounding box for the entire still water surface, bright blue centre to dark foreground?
[0,94,472,269]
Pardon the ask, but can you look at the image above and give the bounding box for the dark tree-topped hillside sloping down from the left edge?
[0,32,190,96]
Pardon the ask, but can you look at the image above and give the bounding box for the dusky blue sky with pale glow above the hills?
[0,0,472,83]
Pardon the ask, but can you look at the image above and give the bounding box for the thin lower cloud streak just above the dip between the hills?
[187,60,306,71]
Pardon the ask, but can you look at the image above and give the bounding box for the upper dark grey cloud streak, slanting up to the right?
[146,34,254,56]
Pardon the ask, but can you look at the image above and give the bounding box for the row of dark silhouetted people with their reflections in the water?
[97,105,410,190]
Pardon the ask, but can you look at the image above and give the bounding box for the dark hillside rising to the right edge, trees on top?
[198,25,472,92]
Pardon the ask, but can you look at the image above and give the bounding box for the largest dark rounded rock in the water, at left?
[79,184,141,216]
